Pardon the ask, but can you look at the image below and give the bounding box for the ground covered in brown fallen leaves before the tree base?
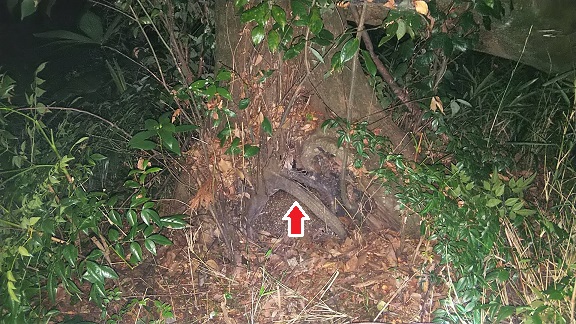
[58,204,445,324]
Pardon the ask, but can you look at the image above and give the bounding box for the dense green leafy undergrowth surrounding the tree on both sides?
[0,1,576,323]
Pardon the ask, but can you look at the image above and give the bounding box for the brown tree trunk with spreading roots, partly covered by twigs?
[215,0,418,237]
